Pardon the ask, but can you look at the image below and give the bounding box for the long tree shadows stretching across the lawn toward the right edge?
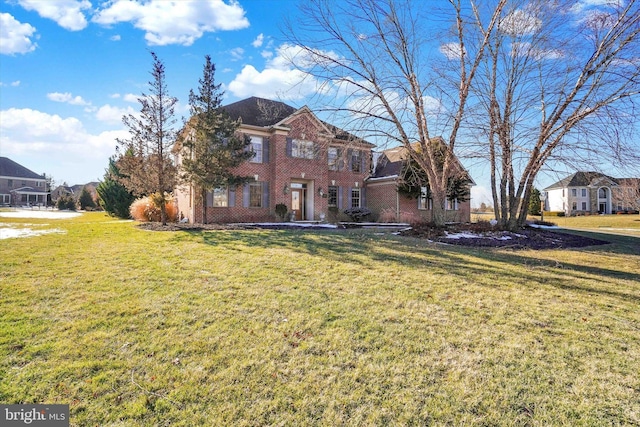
[189,230,640,303]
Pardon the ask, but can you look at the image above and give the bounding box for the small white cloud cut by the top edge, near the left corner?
[18,0,91,31]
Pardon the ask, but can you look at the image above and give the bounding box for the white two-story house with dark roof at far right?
[543,172,637,215]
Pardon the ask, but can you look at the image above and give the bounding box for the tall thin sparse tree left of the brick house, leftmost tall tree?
[118,52,178,225]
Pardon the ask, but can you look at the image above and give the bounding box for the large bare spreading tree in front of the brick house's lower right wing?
[285,0,507,225]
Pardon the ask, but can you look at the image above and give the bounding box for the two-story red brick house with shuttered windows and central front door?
[174,97,374,222]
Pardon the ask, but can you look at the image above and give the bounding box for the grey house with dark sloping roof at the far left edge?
[0,157,49,206]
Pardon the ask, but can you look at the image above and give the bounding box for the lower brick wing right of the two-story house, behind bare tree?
[366,145,475,222]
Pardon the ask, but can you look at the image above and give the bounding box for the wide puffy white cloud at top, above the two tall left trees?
[93,0,249,46]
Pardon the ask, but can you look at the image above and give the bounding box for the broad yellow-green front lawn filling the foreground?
[0,213,640,426]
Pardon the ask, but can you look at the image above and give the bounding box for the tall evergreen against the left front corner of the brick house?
[180,55,254,223]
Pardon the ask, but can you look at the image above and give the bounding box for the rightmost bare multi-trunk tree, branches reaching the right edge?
[465,0,640,229]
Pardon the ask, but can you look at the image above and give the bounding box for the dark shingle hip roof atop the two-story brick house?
[222,96,297,126]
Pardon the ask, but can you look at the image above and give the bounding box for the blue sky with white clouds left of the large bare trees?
[0,0,632,205]
